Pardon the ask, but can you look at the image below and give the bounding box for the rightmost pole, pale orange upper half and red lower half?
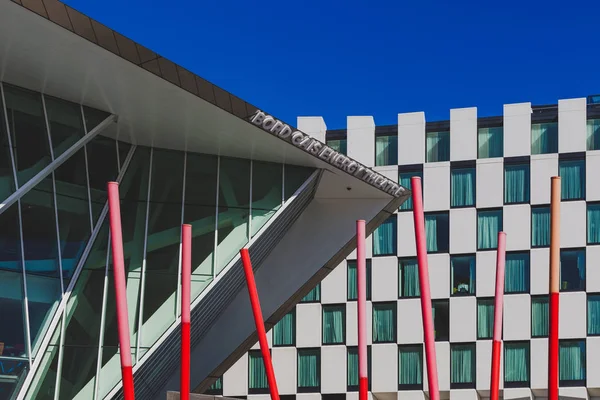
[548,176,560,400]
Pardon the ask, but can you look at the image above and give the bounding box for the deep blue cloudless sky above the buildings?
[65,0,600,129]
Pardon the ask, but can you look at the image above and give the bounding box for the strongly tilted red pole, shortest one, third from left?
[240,249,279,400]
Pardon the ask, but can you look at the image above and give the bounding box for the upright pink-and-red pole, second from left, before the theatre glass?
[180,224,192,400]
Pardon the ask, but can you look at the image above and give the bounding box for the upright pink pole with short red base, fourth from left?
[356,220,369,400]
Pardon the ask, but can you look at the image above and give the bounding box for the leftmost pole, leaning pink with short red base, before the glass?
[107,182,135,400]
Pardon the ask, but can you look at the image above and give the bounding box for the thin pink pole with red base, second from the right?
[490,232,506,400]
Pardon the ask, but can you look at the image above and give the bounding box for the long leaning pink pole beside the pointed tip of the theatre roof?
[410,176,440,400]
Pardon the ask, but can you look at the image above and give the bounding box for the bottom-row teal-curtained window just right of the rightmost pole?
[558,340,585,386]
